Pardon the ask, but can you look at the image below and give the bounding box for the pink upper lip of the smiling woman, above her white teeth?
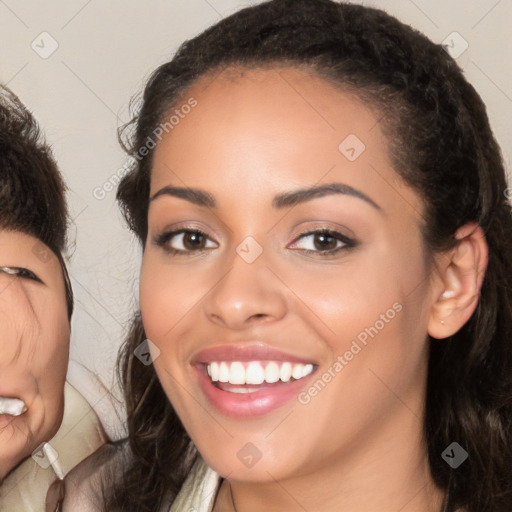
[192,341,315,364]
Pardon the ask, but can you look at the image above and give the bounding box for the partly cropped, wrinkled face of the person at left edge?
[0,231,70,479]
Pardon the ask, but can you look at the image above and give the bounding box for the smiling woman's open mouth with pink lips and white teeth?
[193,346,317,418]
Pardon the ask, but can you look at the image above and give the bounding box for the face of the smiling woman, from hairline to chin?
[140,68,440,481]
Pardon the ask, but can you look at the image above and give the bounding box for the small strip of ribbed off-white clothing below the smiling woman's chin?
[169,458,221,512]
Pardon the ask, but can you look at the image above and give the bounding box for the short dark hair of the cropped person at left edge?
[0,85,73,318]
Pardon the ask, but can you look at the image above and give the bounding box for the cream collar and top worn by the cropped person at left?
[0,382,106,512]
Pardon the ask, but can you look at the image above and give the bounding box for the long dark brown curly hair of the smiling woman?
[107,0,512,512]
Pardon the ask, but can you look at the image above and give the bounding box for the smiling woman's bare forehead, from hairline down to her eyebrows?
[151,67,417,216]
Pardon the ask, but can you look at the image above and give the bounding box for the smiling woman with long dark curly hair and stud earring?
[64,0,512,512]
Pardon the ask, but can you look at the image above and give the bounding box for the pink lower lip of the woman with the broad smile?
[196,367,315,418]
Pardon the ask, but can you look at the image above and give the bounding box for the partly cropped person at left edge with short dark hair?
[0,87,105,512]
